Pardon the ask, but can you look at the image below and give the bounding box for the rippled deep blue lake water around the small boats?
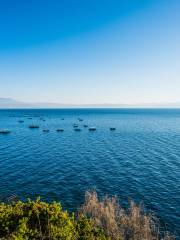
[0,109,180,236]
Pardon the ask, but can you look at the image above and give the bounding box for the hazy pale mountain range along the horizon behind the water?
[0,98,180,109]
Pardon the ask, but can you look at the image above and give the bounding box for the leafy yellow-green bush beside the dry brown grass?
[0,199,107,240]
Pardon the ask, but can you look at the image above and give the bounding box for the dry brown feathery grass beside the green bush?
[80,191,174,240]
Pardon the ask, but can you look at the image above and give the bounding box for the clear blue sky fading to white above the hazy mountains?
[0,0,180,104]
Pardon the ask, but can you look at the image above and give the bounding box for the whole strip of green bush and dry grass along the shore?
[0,191,174,240]
